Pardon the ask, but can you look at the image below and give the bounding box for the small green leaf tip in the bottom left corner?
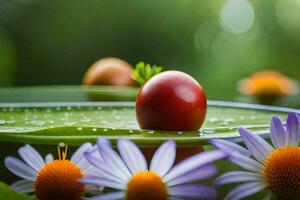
[0,182,35,200]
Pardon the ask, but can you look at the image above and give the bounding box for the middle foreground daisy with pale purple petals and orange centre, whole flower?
[81,138,227,200]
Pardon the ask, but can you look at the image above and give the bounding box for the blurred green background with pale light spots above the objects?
[0,0,300,102]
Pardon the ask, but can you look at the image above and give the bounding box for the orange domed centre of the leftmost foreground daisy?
[34,160,84,200]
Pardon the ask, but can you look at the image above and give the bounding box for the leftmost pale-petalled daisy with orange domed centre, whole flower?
[4,143,95,200]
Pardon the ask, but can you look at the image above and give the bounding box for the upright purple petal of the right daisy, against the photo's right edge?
[286,113,300,147]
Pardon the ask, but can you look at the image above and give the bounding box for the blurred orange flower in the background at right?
[238,70,297,102]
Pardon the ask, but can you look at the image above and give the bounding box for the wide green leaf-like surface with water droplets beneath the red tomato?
[0,101,299,147]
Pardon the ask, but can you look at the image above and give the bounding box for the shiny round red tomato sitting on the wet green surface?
[136,71,207,131]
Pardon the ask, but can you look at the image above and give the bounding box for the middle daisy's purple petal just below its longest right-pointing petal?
[167,164,217,187]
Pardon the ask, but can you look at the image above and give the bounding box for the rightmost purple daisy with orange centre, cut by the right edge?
[211,113,300,200]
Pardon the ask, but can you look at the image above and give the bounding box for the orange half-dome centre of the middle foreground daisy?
[126,171,168,200]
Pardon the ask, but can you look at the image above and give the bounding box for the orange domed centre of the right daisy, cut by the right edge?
[264,147,300,199]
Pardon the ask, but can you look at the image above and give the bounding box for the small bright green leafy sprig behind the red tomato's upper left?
[132,61,162,85]
